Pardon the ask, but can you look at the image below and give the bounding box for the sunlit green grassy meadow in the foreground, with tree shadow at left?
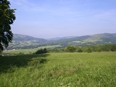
[0,52,116,87]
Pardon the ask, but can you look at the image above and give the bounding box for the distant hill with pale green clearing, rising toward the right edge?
[52,33,116,46]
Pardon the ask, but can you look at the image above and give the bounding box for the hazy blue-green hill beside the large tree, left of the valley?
[8,34,47,49]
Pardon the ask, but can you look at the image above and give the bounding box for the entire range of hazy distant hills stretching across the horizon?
[9,33,116,49]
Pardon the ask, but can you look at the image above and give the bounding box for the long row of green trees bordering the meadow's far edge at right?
[49,44,116,53]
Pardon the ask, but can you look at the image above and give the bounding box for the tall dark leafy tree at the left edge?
[0,0,16,52]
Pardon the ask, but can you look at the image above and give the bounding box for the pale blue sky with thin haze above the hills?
[9,0,116,38]
